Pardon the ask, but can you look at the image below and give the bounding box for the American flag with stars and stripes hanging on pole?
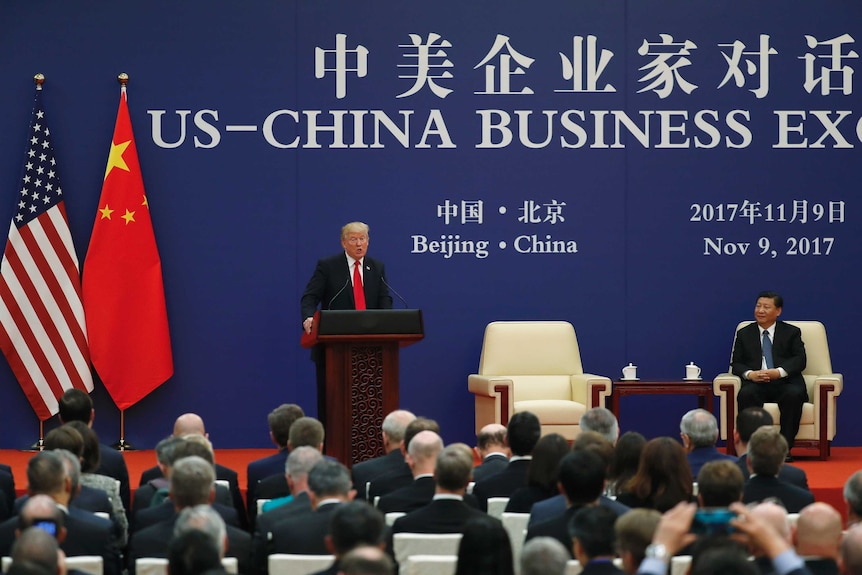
[0,86,93,421]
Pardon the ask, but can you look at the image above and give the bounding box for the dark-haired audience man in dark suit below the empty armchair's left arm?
[473,411,542,511]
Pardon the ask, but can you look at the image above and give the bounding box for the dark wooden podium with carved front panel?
[301,309,425,467]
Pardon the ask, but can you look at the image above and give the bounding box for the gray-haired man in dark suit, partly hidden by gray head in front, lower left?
[128,455,251,575]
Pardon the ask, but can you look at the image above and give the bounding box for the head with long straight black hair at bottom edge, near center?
[455,515,515,575]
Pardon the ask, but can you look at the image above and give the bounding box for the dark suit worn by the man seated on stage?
[731,321,808,447]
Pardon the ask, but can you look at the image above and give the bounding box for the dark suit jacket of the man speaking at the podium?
[300,252,392,320]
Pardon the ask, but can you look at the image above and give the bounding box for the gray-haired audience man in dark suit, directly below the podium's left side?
[266,459,356,566]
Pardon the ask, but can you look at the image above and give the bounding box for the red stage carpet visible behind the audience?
[0,447,862,515]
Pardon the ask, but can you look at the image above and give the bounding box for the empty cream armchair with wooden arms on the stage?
[467,321,611,440]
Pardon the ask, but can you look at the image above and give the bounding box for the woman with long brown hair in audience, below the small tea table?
[617,437,692,513]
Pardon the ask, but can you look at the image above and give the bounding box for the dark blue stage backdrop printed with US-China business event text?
[0,0,862,448]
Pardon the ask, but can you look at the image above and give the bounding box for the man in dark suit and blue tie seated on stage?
[731,291,808,461]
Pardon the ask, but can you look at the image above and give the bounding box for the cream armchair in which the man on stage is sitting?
[712,321,844,459]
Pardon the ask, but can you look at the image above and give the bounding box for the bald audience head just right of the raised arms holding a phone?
[793,503,844,575]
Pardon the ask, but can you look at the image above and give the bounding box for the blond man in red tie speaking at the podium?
[300,222,392,421]
